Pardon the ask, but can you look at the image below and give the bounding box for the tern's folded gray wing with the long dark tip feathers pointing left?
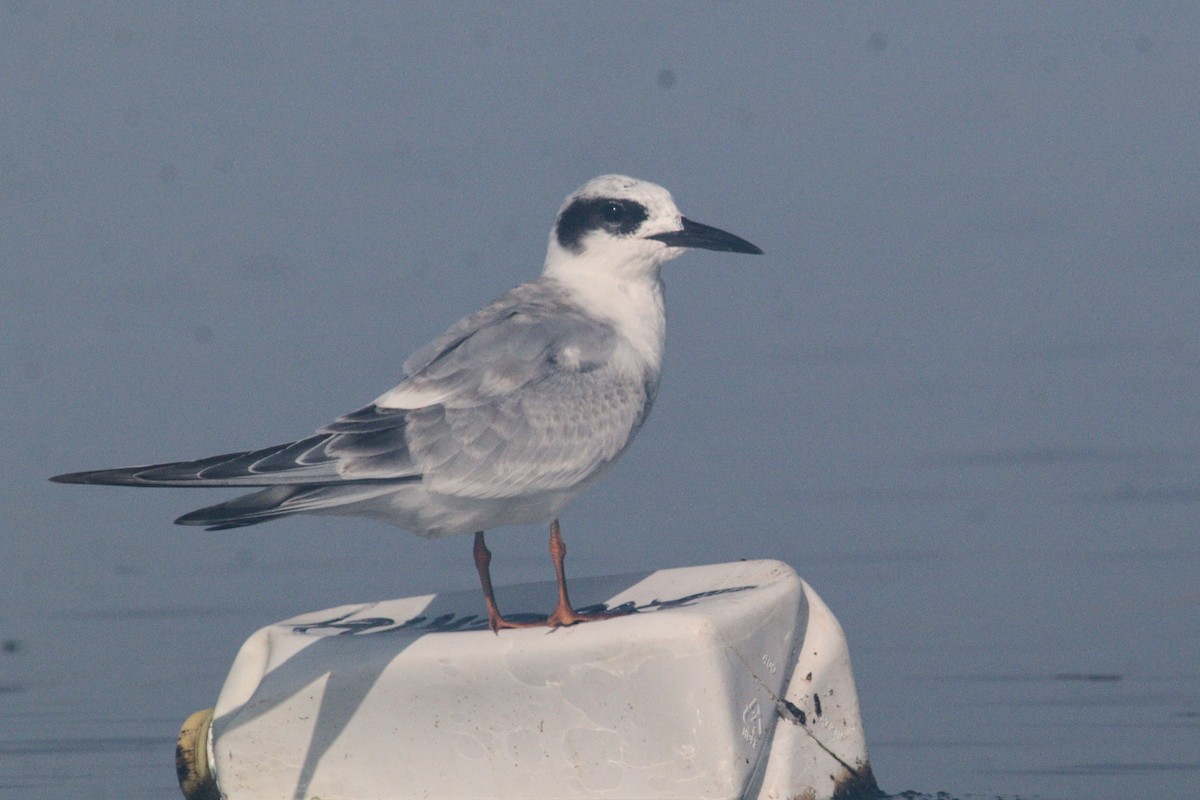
[52,282,658,528]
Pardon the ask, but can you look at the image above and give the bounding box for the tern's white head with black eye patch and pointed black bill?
[546,175,762,278]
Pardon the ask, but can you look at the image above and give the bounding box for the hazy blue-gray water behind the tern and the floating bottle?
[0,6,1200,800]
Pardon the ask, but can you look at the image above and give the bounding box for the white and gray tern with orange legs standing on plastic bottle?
[50,175,762,631]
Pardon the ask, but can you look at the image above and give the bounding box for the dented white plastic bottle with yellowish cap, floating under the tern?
[179,561,881,800]
